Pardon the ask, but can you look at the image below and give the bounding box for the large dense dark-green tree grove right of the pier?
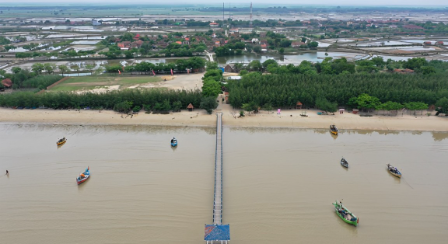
[229,73,448,107]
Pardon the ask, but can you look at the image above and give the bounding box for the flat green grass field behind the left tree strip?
[50,76,162,91]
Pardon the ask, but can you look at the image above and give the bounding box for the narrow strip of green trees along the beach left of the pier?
[0,89,202,112]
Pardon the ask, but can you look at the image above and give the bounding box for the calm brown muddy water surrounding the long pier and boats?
[0,124,448,244]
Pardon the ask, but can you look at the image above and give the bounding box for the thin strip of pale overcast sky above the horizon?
[0,0,448,6]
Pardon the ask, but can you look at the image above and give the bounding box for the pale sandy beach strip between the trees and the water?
[0,107,448,132]
